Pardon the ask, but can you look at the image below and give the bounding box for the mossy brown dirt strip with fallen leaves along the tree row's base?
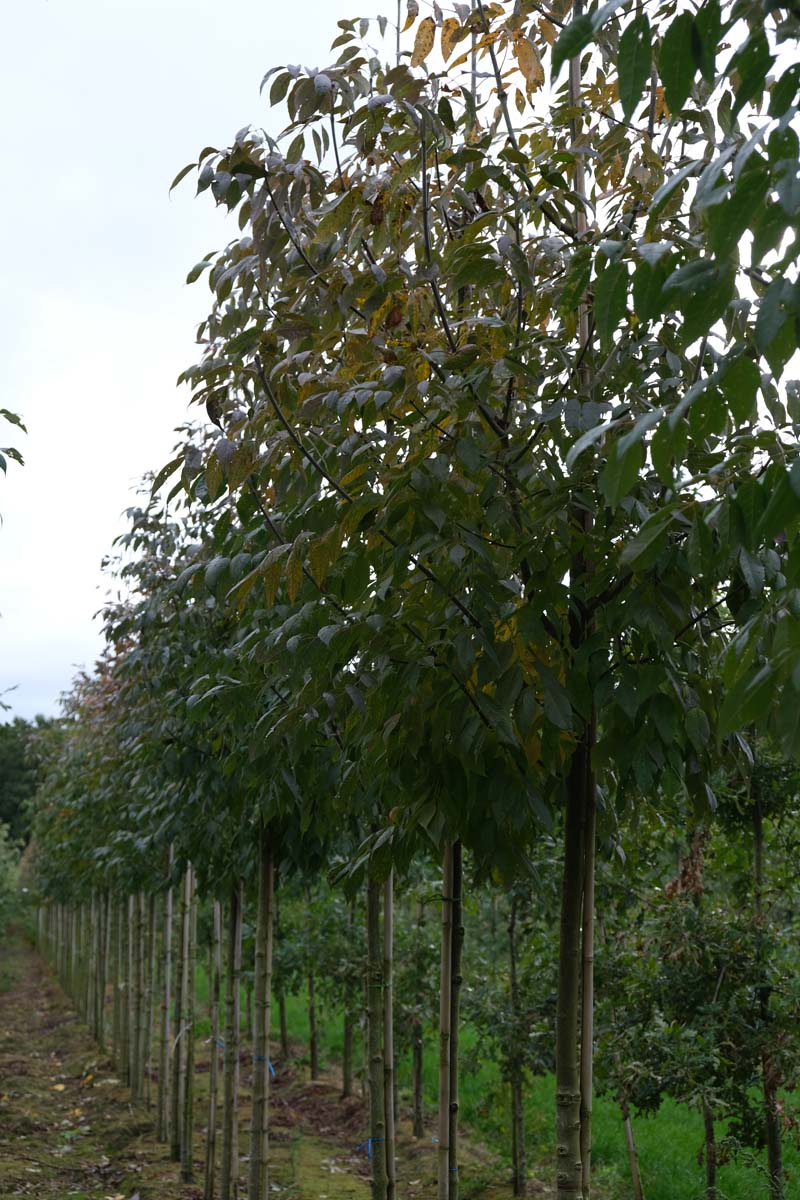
[0,942,509,1200]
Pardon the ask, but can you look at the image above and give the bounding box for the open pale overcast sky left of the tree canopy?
[0,0,395,720]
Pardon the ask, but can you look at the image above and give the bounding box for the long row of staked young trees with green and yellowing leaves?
[10,0,800,1200]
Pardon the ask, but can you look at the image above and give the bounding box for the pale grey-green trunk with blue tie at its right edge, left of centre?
[247,824,275,1200]
